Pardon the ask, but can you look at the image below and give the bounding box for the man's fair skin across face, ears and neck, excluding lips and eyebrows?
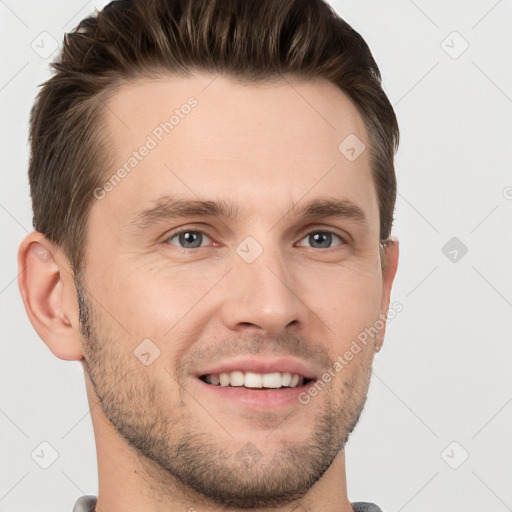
[19,74,398,512]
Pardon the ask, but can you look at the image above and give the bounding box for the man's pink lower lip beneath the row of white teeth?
[195,378,315,410]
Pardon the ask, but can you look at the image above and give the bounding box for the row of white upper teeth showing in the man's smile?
[201,370,304,389]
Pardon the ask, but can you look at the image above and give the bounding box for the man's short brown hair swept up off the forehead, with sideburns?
[29,0,399,271]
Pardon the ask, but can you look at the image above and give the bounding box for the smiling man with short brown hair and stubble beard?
[19,0,398,512]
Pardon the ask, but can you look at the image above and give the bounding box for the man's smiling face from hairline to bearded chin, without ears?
[77,75,396,508]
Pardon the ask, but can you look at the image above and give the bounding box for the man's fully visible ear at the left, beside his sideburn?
[18,231,83,361]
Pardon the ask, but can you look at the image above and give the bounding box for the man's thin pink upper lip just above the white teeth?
[196,357,316,379]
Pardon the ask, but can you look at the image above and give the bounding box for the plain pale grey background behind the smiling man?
[0,0,512,512]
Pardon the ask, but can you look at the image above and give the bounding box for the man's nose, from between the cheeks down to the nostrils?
[221,246,309,337]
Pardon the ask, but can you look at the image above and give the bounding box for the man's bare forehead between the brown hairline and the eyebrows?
[95,74,378,230]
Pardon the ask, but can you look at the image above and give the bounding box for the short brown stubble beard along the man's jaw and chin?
[75,272,371,510]
